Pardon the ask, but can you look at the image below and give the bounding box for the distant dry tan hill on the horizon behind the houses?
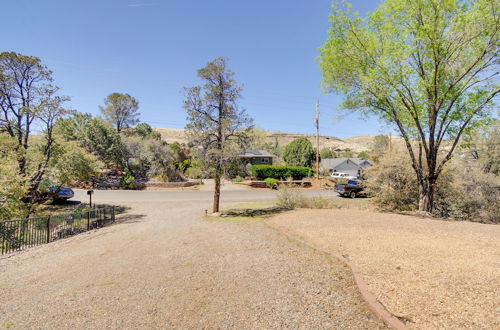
[155,127,403,153]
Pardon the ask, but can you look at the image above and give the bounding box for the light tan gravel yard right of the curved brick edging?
[266,209,500,329]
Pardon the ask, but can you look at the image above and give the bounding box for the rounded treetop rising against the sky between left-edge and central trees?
[99,93,139,133]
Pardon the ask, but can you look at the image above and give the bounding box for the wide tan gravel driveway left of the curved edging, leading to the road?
[0,194,385,329]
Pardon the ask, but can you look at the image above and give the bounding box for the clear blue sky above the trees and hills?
[0,0,386,137]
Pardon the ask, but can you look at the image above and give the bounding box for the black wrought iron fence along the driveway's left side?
[0,206,115,254]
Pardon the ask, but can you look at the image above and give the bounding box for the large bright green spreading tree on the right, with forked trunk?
[320,0,500,212]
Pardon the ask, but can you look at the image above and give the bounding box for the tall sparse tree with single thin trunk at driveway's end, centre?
[184,57,252,213]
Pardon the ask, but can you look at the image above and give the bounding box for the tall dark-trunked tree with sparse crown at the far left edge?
[0,52,70,206]
